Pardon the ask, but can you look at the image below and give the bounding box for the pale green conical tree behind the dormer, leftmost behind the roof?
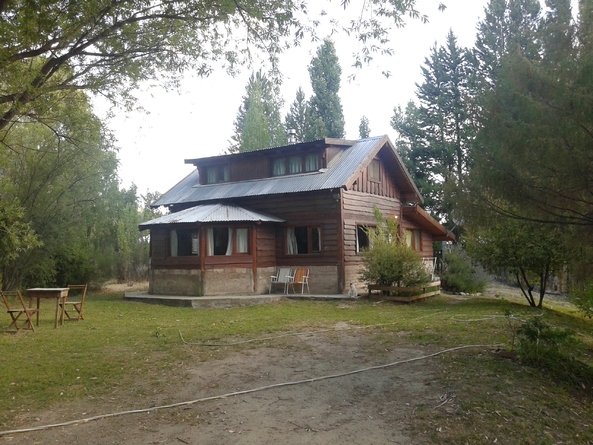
[229,70,287,153]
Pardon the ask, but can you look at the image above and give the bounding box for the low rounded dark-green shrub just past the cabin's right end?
[441,252,486,294]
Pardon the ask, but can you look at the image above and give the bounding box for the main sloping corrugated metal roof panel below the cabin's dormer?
[153,137,384,207]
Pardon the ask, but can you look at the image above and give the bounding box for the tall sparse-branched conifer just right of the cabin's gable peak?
[391,31,476,219]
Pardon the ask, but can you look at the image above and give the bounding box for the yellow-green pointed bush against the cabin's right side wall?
[360,208,430,287]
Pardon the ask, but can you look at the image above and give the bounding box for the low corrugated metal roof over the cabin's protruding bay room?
[138,204,284,230]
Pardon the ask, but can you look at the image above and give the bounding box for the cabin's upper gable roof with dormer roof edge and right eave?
[152,136,423,207]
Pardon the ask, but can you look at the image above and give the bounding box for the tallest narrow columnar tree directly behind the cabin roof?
[307,39,344,140]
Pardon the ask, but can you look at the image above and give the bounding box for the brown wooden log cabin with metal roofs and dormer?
[140,136,453,296]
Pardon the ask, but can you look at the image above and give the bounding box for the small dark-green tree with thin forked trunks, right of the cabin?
[465,216,566,308]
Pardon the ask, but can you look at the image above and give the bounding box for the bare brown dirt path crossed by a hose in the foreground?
[0,331,443,445]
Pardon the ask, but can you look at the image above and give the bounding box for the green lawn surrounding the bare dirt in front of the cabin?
[0,284,593,444]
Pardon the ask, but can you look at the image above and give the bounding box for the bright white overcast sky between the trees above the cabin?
[97,0,487,194]
